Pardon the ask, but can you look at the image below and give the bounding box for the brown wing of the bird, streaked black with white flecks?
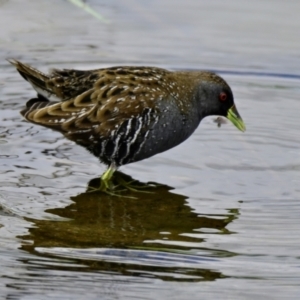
[22,67,174,144]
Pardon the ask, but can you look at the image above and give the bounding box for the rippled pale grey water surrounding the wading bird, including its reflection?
[0,0,300,299]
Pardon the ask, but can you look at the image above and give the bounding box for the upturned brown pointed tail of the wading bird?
[8,59,52,95]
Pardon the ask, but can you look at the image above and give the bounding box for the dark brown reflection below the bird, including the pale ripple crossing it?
[22,175,238,281]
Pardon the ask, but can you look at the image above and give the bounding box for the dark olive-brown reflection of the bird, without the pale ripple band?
[22,173,237,281]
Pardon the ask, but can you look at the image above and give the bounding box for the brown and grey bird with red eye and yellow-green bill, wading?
[8,59,246,193]
